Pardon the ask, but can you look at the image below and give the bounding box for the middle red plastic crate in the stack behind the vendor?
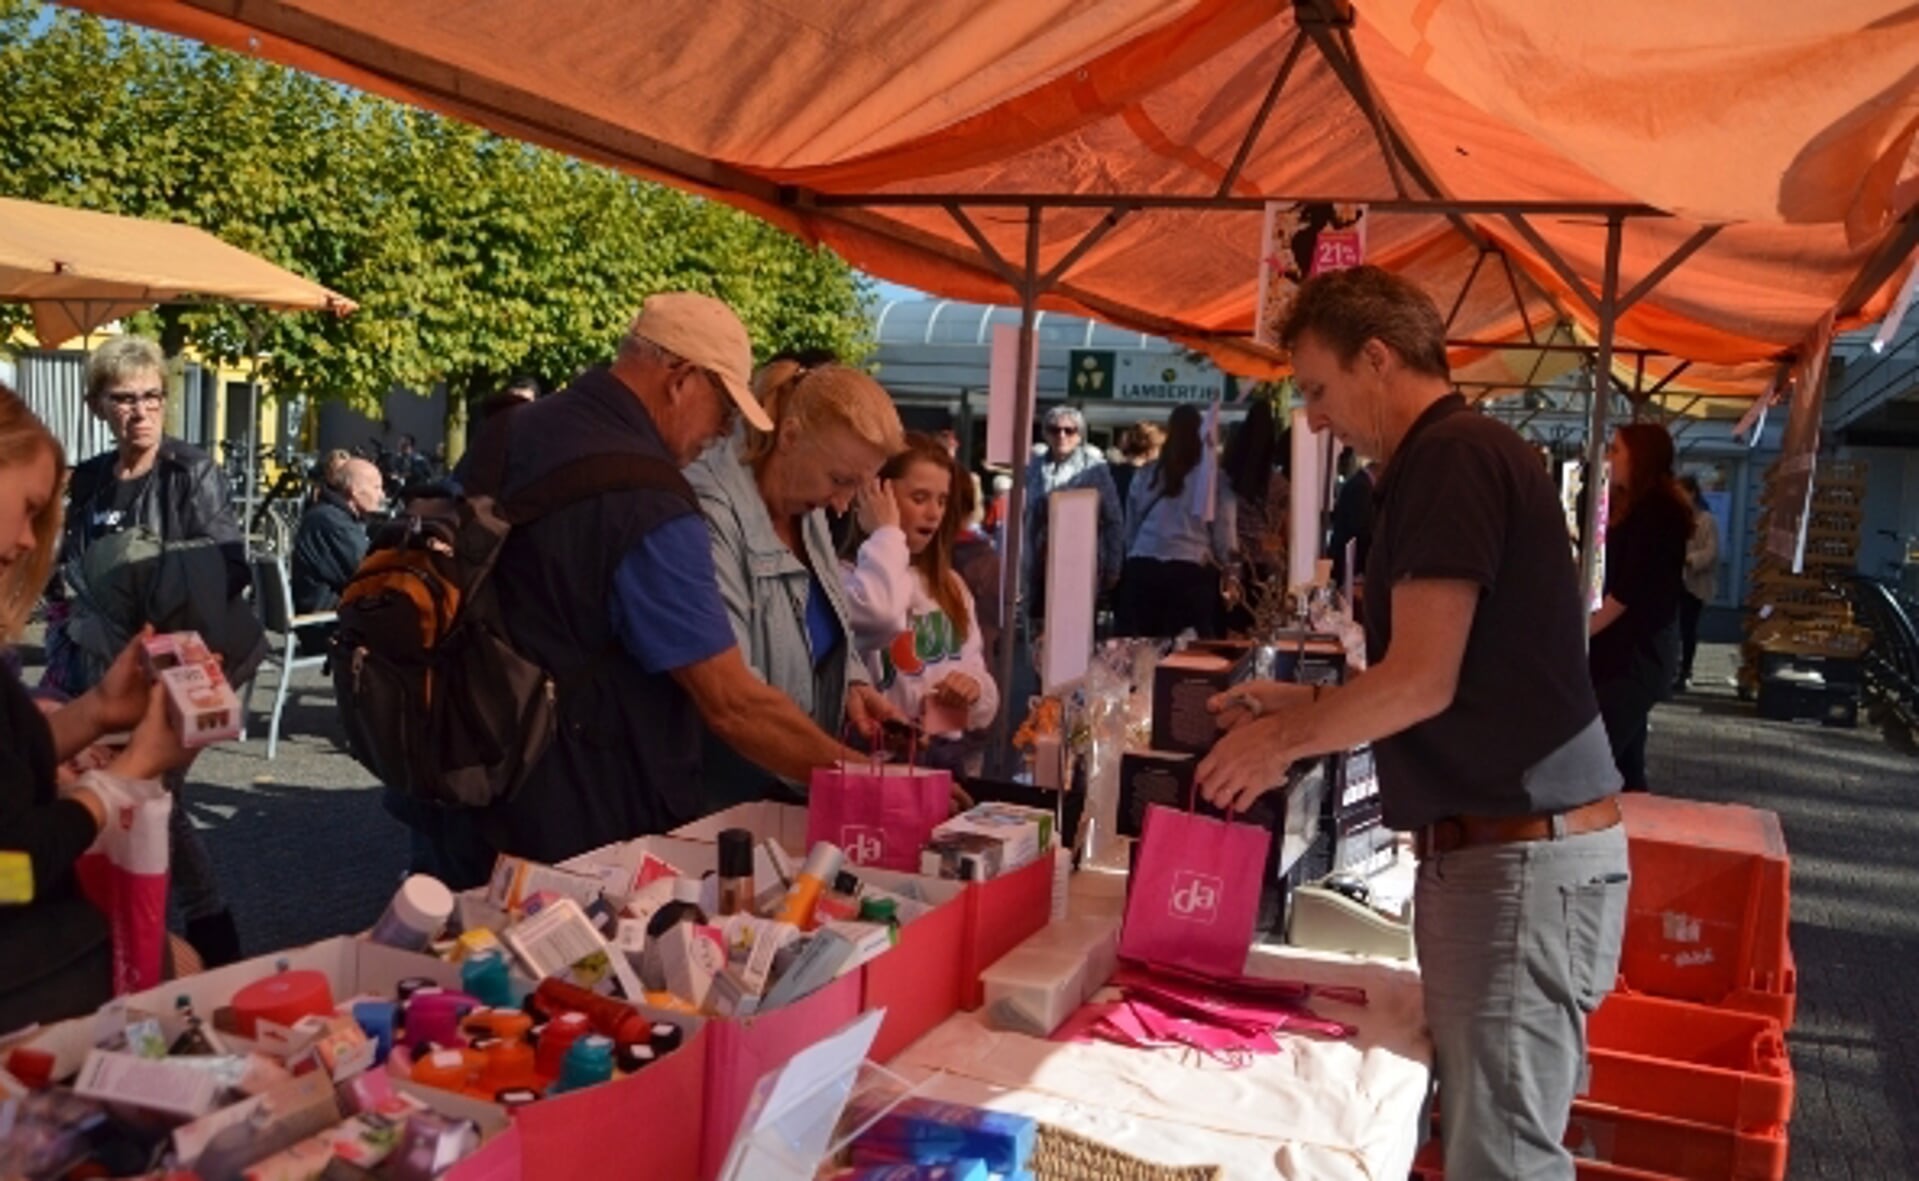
[1581,993,1792,1129]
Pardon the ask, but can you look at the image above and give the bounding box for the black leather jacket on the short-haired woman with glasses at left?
[59,438,251,599]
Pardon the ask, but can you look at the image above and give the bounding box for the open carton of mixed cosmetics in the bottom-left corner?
[0,937,505,1181]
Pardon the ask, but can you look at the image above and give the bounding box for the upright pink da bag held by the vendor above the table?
[1119,805,1272,977]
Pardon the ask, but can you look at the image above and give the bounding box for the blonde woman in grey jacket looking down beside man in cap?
[687,361,904,807]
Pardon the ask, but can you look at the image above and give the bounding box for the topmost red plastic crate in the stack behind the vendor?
[1620,793,1796,1024]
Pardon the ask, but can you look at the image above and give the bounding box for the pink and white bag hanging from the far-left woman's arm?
[73,780,173,997]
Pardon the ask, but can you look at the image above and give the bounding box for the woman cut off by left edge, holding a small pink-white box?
[0,386,192,1035]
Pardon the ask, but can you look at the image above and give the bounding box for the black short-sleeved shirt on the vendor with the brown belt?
[1366,394,1620,830]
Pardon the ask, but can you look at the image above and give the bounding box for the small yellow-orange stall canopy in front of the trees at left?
[0,198,355,348]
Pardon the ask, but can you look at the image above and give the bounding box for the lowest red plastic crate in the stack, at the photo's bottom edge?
[1566,1100,1787,1181]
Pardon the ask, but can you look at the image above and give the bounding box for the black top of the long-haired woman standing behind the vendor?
[1589,495,1693,687]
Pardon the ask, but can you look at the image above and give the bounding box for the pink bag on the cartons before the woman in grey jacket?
[806,762,954,874]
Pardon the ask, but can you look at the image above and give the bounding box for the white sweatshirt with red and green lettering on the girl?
[841,526,1000,737]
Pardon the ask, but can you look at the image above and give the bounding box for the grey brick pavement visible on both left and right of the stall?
[18,647,1919,1181]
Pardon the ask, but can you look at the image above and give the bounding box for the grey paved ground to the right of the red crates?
[1648,647,1919,1181]
